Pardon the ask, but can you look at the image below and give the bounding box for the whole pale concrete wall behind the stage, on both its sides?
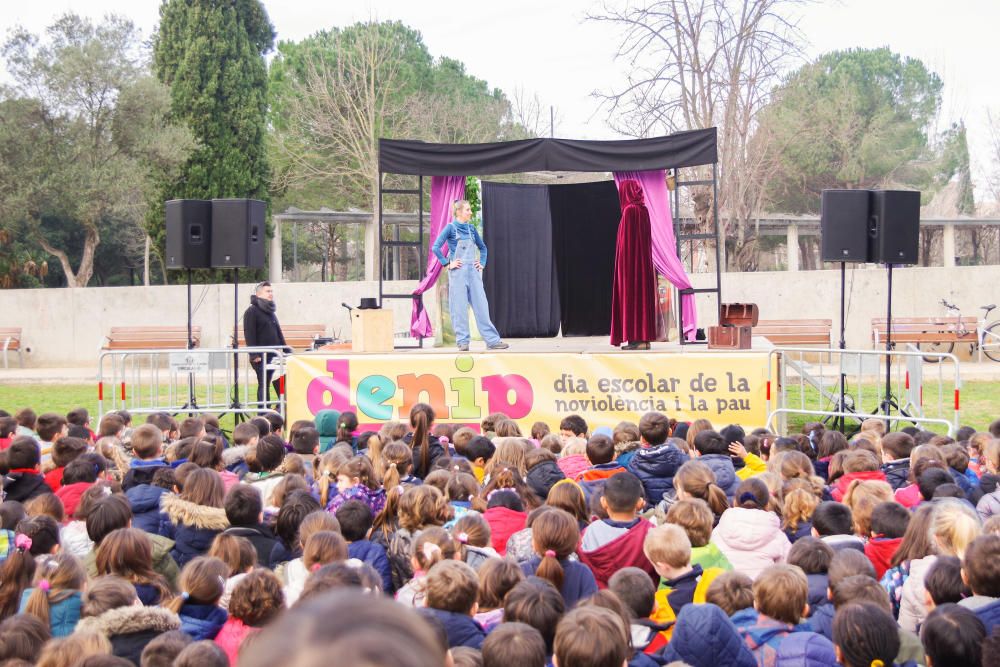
[0,266,1000,366]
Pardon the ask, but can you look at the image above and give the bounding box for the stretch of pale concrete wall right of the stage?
[692,264,1000,352]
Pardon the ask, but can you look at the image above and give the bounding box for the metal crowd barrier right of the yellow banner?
[767,345,962,435]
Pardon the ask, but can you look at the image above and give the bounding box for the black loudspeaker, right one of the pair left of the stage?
[212,199,267,269]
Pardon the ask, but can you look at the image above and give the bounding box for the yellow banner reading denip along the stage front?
[286,352,768,430]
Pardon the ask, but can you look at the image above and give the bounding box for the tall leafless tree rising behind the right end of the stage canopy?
[590,0,801,270]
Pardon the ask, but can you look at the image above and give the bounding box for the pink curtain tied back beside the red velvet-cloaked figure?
[615,169,698,340]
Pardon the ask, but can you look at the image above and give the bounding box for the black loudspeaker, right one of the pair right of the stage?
[869,190,920,264]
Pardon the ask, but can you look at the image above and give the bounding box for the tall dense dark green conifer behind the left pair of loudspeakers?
[150,0,275,276]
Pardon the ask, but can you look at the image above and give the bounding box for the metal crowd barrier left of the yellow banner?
[97,347,288,417]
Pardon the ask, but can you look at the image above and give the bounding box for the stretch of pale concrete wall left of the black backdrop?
[0,281,437,366]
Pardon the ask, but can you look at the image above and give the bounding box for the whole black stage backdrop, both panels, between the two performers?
[483,181,621,338]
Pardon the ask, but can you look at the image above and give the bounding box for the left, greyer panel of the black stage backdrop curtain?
[483,181,560,338]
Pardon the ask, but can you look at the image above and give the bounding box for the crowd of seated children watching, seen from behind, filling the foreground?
[0,404,1000,667]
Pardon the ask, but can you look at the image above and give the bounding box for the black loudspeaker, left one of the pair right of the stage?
[819,190,871,262]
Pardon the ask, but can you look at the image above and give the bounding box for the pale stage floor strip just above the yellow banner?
[310,336,774,356]
